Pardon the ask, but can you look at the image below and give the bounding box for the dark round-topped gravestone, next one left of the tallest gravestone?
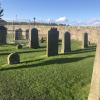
[30,28,39,49]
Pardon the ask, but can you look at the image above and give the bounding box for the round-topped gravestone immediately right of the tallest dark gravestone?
[62,32,71,53]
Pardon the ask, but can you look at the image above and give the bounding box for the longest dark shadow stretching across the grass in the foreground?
[0,55,94,71]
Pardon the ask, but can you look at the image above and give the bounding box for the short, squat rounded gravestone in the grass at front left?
[7,52,20,64]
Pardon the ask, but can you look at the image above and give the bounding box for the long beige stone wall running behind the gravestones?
[6,25,100,43]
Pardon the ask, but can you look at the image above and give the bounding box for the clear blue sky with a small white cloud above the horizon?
[0,0,100,24]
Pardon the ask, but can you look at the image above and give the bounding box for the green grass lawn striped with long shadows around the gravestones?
[0,41,95,100]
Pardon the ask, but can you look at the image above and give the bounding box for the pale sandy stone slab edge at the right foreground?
[88,35,100,100]
